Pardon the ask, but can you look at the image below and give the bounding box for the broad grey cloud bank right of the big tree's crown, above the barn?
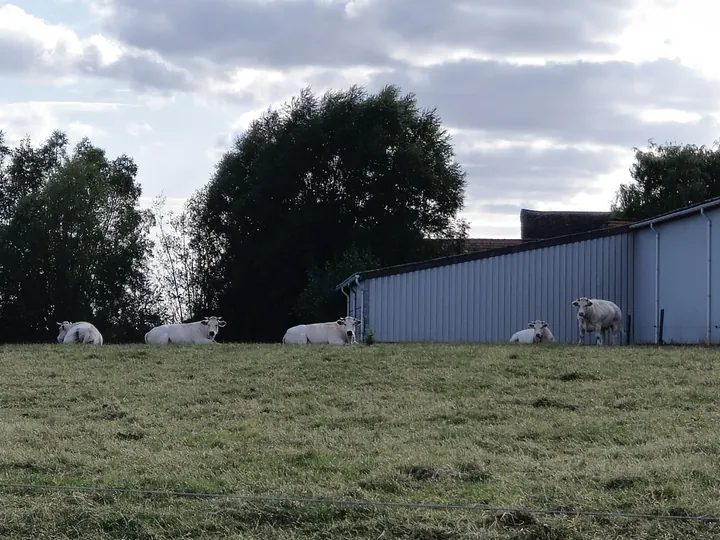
[380,60,719,147]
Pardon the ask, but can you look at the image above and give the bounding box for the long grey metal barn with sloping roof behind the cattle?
[337,197,720,343]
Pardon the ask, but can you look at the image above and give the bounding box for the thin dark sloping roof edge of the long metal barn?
[335,197,720,290]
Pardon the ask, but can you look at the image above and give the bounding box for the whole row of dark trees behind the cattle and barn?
[0,86,720,343]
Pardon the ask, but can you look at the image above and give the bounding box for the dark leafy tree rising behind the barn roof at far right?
[612,142,720,223]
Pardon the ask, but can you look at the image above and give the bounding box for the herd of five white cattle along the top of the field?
[57,296,624,345]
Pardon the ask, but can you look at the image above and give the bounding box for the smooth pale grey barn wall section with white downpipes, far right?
[633,209,720,344]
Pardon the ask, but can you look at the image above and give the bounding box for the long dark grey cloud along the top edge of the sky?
[100,0,635,67]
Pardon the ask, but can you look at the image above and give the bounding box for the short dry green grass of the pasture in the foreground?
[0,344,720,540]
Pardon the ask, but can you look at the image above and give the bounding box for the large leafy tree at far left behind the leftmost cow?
[0,131,159,341]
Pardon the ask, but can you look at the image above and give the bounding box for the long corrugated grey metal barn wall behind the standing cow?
[352,233,634,343]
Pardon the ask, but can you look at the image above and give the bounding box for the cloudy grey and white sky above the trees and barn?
[0,0,720,238]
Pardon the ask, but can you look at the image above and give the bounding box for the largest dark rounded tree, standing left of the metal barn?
[193,86,468,341]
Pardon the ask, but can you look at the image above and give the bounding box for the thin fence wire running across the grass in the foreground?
[0,483,720,523]
